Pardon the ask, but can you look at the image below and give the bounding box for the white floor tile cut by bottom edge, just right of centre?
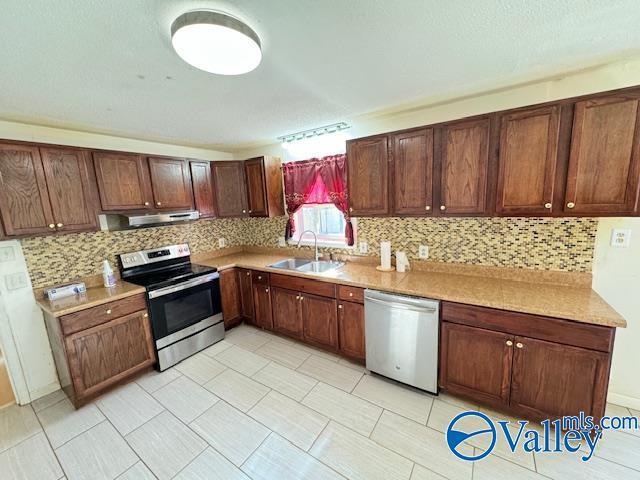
[309,422,413,480]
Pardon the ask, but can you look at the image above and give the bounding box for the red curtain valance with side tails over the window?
[282,154,353,246]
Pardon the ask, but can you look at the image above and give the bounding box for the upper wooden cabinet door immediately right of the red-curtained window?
[347,136,390,216]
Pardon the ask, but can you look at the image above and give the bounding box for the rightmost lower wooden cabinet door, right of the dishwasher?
[511,337,609,418]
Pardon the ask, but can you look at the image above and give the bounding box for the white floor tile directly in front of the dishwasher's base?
[353,375,433,424]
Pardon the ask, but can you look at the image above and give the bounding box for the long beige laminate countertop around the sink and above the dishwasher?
[196,252,627,327]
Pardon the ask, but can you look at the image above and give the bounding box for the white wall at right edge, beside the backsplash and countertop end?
[593,218,640,410]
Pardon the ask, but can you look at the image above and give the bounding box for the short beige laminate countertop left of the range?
[36,280,146,317]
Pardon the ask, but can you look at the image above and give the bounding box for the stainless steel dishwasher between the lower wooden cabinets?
[364,289,440,394]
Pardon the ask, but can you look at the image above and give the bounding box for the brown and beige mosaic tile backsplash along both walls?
[22,217,598,288]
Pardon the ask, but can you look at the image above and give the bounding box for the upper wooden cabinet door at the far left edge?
[0,144,55,236]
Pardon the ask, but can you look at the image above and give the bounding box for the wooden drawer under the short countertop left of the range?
[60,293,147,335]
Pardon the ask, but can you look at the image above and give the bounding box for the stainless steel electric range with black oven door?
[118,244,224,371]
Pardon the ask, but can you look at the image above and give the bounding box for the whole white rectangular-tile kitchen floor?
[0,326,640,480]
